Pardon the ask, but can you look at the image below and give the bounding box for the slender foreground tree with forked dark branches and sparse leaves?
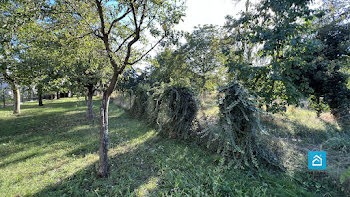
[56,0,183,177]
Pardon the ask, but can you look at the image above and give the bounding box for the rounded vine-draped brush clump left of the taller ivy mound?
[131,84,198,139]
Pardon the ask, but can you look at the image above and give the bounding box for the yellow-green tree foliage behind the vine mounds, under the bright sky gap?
[150,25,226,93]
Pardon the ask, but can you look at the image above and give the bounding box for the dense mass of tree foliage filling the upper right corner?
[224,0,350,124]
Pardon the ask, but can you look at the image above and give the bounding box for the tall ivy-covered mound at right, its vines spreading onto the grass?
[202,82,278,168]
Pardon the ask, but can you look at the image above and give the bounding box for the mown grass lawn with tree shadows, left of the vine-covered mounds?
[0,98,344,197]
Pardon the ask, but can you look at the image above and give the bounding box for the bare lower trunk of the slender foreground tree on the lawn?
[98,92,110,177]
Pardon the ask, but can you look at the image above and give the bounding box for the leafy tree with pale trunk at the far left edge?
[0,0,46,114]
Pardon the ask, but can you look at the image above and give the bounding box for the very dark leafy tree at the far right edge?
[301,23,350,123]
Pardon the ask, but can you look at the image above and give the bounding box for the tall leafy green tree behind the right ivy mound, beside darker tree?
[225,0,315,110]
